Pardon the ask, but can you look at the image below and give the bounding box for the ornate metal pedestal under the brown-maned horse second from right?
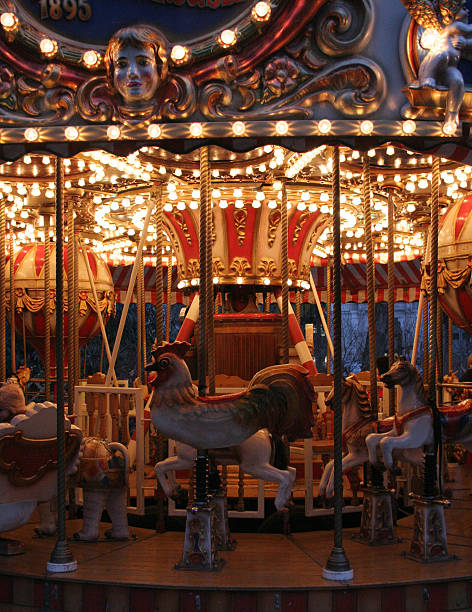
[353,488,397,546]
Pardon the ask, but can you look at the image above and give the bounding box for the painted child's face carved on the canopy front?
[113,46,159,106]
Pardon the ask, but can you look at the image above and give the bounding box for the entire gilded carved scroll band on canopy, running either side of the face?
[0,0,386,125]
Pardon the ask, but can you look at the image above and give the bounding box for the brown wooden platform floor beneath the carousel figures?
[0,465,472,612]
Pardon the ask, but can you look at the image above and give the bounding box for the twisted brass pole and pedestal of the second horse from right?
[357,155,395,546]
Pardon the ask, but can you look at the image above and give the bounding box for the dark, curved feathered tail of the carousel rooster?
[248,364,315,442]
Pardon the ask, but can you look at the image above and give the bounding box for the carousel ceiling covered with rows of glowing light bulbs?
[0,144,464,301]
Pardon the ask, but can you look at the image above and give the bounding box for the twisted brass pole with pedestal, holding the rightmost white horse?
[408,157,450,562]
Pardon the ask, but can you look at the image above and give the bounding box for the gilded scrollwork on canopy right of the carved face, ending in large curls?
[200,0,386,119]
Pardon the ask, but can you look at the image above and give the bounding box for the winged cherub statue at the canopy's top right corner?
[402,0,472,133]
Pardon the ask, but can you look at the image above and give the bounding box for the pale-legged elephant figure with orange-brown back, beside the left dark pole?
[73,437,129,542]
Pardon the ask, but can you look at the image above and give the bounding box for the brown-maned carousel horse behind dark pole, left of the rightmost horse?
[319,375,377,498]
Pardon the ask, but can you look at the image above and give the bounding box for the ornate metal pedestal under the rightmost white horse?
[407,496,453,563]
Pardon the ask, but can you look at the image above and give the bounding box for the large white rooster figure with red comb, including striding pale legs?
[147,342,314,510]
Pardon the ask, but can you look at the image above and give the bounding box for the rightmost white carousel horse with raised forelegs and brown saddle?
[366,359,472,468]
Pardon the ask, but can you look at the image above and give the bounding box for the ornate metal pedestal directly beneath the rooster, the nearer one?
[175,502,224,571]
